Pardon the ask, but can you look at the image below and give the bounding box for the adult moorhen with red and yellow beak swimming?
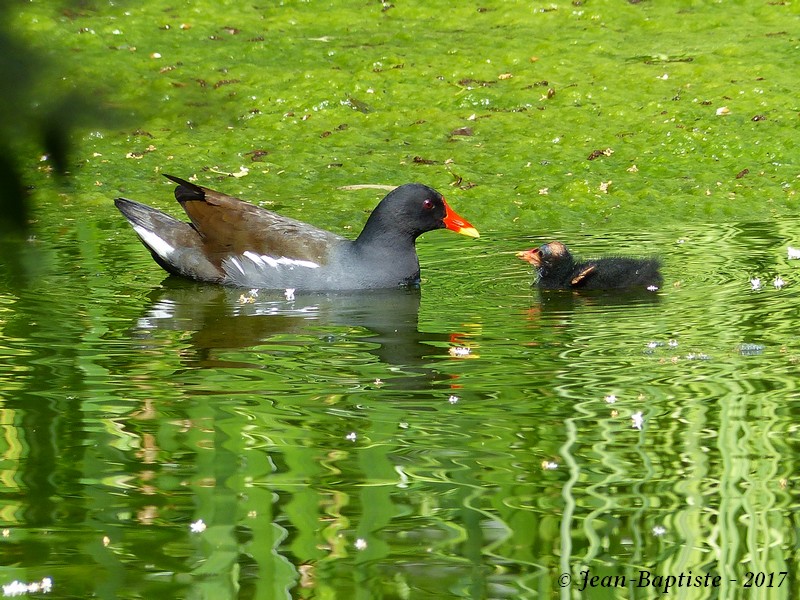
[114,175,478,290]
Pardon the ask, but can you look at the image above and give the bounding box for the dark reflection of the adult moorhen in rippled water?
[135,277,466,390]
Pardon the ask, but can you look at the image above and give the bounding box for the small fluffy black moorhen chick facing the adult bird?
[517,242,663,291]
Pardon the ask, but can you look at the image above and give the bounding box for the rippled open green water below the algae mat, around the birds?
[2,213,800,598]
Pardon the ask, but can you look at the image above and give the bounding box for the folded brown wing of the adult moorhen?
[167,175,344,264]
